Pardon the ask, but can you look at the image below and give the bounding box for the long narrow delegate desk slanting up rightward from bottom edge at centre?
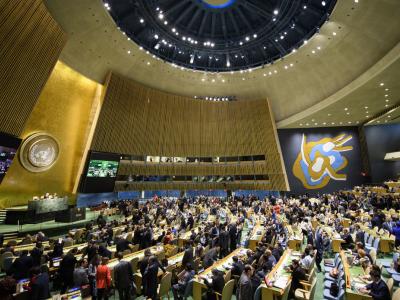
[193,248,247,300]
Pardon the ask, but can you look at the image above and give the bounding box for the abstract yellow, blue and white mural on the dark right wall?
[292,134,353,189]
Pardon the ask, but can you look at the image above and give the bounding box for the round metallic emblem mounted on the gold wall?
[20,133,59,172]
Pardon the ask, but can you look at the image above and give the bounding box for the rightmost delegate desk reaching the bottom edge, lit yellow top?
[340,251,372,300]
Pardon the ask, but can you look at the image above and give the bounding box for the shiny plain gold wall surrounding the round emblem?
[0,62,100,207]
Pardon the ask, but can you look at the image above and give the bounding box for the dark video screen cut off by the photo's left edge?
[0,133,21,183]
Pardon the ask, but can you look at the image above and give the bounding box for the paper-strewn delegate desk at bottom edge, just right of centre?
[261,249,301,300]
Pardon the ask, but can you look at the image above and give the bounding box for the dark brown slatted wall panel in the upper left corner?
[0,0,66,136]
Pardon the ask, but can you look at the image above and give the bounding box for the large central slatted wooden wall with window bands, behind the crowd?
[91,73,287,190]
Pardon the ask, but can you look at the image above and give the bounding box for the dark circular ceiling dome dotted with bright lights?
[104,0,336,72]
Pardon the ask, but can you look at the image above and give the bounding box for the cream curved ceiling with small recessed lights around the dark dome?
[46,0,400,128]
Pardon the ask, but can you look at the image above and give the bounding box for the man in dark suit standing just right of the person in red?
[114,252,133,300]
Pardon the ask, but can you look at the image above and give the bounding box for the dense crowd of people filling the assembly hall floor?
[0,183,400,300]
